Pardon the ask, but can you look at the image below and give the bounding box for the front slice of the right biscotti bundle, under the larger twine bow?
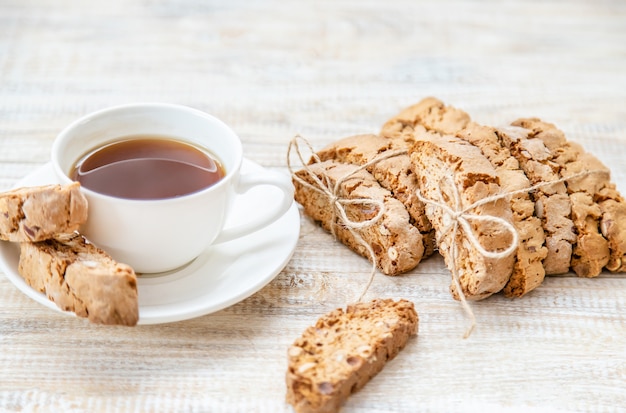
[409,132,515,300]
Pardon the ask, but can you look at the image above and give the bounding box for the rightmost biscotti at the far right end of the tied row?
[513,118,626,277]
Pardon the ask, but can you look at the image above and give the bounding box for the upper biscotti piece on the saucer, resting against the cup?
[0,182,87,242]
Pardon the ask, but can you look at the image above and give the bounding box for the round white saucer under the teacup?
[0,159,300,324]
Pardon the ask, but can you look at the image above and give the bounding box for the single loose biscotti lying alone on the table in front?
[286,299,418,413]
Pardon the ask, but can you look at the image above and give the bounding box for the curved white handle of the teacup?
[213,171,294,244]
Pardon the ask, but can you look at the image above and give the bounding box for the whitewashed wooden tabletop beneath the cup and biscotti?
[0,0,626,412]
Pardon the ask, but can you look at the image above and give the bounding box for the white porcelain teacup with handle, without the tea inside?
[52,103,293,273]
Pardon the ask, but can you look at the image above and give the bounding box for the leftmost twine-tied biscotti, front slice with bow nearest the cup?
[293,161,424,275]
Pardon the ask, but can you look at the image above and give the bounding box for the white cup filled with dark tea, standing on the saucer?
[52,103,293,273]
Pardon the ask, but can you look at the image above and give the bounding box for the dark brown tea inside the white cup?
[70,136,225,199]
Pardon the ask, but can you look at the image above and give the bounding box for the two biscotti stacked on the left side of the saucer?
[0,183,139,326]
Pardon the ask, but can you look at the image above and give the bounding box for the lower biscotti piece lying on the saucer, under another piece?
[18,234,139,326]
